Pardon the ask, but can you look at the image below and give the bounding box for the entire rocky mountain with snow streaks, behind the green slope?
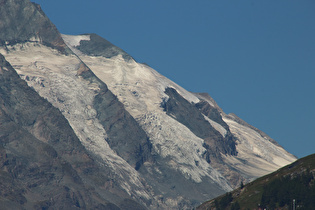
[0,0,296,209]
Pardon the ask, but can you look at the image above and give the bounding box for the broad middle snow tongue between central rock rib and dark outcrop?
[61,34,232,191]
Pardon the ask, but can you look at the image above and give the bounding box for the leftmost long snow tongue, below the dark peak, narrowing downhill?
[0,43,152,199]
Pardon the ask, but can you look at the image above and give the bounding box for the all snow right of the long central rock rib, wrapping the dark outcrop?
[63,35,296,182]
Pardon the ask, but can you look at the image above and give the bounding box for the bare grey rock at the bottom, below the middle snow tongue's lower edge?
[139,158,225,209]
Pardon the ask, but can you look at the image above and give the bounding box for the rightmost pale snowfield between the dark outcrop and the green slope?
[223,117,296,177]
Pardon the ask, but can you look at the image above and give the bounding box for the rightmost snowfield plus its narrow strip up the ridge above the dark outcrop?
[195,94,297,181]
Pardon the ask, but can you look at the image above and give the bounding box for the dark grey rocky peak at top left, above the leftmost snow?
[0,0,70,53]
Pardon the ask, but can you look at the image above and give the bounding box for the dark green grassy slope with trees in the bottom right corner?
[197,154,315,210]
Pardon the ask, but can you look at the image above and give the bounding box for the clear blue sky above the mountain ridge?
[33,0,315,158]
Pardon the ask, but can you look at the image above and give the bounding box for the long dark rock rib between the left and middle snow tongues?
[80,65,153,170]
